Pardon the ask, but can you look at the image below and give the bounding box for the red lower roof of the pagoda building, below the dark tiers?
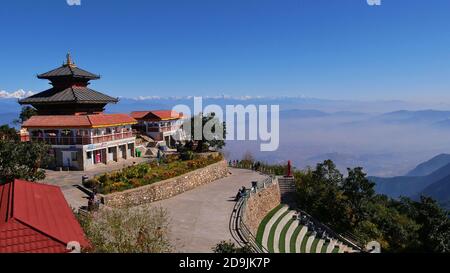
[22,114,136,128]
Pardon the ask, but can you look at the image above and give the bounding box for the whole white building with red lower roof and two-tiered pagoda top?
[19,55,137,170]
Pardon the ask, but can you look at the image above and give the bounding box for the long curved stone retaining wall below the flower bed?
[102,160,228,208]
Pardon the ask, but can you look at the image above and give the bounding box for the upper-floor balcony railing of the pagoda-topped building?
[31,132,133,145]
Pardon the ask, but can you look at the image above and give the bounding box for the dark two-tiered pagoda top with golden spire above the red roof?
[19,54,118,115]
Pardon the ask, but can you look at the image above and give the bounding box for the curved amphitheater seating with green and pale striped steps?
[256,205,355,253]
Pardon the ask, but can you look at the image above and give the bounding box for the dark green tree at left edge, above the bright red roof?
[0,140,50,183]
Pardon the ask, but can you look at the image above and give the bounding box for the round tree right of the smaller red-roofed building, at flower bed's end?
[184,113,226,153]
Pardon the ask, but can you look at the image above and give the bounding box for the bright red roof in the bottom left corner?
[0,180,90,253]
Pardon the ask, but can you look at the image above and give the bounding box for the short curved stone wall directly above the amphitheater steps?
[244,180,281,236]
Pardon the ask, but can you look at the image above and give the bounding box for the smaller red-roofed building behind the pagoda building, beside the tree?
[130,110,186,147]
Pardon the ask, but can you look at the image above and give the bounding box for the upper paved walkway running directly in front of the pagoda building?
[39,157,153,209]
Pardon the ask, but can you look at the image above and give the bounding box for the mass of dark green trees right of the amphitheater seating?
[294,160,450,253]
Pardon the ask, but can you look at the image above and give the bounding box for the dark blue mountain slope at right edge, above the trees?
[370,154,450,209]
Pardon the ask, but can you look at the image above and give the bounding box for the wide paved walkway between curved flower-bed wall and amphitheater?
[144,169,264,253]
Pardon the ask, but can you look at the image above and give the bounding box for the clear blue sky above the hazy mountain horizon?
[0,0,450,100]
